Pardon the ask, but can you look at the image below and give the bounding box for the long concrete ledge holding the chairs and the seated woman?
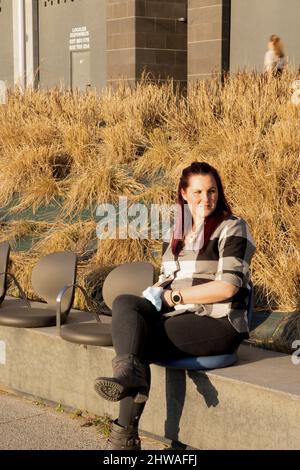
[0,312,300,449]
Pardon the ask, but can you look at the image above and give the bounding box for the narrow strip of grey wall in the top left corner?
[0,0,14,85]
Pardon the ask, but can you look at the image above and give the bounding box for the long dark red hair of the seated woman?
[171,162,232,255]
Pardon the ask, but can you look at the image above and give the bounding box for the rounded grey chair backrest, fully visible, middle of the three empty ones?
[31,251,77,313]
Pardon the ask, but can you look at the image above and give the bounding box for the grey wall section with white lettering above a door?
[39,0,106,89]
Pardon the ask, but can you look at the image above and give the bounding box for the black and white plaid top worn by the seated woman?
[162,215,255,332]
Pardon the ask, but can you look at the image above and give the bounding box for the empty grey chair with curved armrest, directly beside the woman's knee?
[56,263,154,346]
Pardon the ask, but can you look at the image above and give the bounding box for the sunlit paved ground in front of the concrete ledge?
[0,390,166,450]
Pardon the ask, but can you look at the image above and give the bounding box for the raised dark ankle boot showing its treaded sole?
[95,354,149,403]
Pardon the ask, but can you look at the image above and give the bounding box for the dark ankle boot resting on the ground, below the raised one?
[106,420,141,450]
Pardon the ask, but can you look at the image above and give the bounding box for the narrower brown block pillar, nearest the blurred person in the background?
[188,0,230,80]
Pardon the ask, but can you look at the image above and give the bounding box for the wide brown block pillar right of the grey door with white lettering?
[107,0,187,87]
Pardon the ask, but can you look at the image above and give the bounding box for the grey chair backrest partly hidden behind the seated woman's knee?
[102,262,154,308]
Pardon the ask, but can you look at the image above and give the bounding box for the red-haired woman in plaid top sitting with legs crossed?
[95,162,255,450]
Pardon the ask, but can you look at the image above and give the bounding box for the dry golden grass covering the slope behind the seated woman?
[0,72,300,311]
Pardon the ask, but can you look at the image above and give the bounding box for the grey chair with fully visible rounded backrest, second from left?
[0,251,77,328]
